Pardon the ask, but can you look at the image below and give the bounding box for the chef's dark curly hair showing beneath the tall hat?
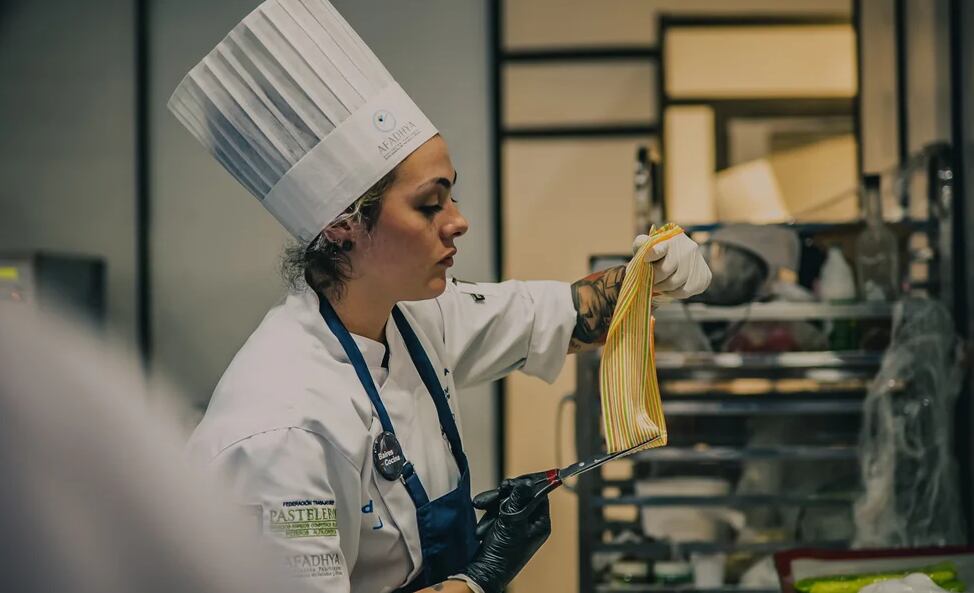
[281,169,396,299]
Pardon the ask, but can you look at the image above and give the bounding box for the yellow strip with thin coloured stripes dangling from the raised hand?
[599,224,683,453]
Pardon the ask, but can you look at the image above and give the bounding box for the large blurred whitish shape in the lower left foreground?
[0,307,297,593]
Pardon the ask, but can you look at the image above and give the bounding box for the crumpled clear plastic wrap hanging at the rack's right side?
[854,299,966,547]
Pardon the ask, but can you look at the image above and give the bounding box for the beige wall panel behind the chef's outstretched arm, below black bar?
[502,140,638,592]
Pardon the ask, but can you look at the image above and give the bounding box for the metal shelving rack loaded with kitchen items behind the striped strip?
[574,92,956,593]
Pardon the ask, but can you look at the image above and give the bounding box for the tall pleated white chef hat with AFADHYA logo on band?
[169,0,437,241]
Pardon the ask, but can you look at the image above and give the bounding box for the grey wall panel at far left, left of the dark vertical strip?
[0,0,136,347]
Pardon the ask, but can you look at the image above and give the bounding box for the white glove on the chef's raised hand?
[632,233,711,299]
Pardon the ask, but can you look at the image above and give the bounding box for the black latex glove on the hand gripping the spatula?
[463,476,551,593]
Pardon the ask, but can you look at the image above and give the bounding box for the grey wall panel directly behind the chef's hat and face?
[151,0,504,488]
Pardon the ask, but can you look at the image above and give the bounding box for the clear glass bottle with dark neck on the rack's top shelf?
[856,175,900,301]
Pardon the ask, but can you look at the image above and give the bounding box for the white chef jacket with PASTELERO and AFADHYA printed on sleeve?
[189,280,576,593]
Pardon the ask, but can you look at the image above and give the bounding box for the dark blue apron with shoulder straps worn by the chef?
[319,298,478,593]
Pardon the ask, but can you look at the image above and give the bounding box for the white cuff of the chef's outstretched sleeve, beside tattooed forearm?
[521,281,577,384]
